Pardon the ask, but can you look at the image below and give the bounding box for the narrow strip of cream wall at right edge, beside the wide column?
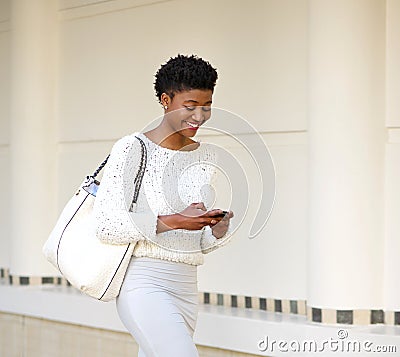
[385,0,400,311]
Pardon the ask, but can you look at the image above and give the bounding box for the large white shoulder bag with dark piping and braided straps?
[42,136,147,301]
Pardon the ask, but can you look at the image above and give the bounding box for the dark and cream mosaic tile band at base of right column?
[307,306,390,325]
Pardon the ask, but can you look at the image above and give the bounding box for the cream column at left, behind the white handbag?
[10,0,58,276]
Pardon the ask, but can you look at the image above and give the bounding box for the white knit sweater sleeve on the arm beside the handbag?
[93,135,158,244]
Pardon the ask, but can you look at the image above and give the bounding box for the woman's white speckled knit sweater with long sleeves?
[93,132,232,265]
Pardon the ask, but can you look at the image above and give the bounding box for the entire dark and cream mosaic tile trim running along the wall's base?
[0,268,400,325]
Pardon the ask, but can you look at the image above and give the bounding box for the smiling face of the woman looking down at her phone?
[161,89,212,137]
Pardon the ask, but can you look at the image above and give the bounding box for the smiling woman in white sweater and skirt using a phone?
[94,55,233,357]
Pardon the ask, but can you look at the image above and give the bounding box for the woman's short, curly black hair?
[154,54,218,103]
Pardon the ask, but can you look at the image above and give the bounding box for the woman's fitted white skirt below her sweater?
[116,256,199,357]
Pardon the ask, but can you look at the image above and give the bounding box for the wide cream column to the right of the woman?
[307,0,386,309]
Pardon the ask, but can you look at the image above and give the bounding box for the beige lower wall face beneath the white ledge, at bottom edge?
[0,313,262,357]
